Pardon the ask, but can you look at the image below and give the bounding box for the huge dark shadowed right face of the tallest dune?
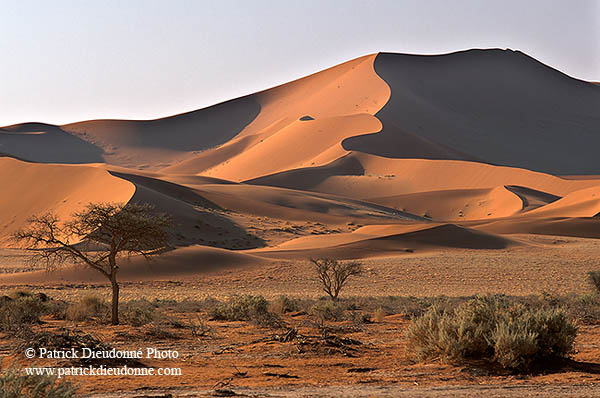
[343,49,600,174]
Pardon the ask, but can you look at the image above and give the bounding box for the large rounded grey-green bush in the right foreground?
[407,296,577,371]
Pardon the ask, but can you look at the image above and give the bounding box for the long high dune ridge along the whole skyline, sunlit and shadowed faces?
[0,49,600,177]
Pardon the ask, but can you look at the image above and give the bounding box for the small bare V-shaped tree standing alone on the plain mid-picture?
[310,258,362,301]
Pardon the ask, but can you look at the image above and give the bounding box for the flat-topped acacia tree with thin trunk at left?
[14,203,171,325]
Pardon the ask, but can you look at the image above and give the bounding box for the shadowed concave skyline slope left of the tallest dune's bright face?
[62,96,260,169]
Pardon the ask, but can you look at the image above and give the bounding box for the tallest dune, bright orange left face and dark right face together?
[165,50,600,181]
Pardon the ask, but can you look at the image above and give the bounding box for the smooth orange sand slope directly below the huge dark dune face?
[247,152,600,199]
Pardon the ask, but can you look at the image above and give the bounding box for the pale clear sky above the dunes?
[0,0,600,126]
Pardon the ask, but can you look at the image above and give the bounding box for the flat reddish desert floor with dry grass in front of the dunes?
[1,235,600,397]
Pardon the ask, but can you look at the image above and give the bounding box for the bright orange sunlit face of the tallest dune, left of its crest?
[162,55,390,181]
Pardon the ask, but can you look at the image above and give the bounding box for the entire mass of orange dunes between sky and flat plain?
[0,49,600,283]
